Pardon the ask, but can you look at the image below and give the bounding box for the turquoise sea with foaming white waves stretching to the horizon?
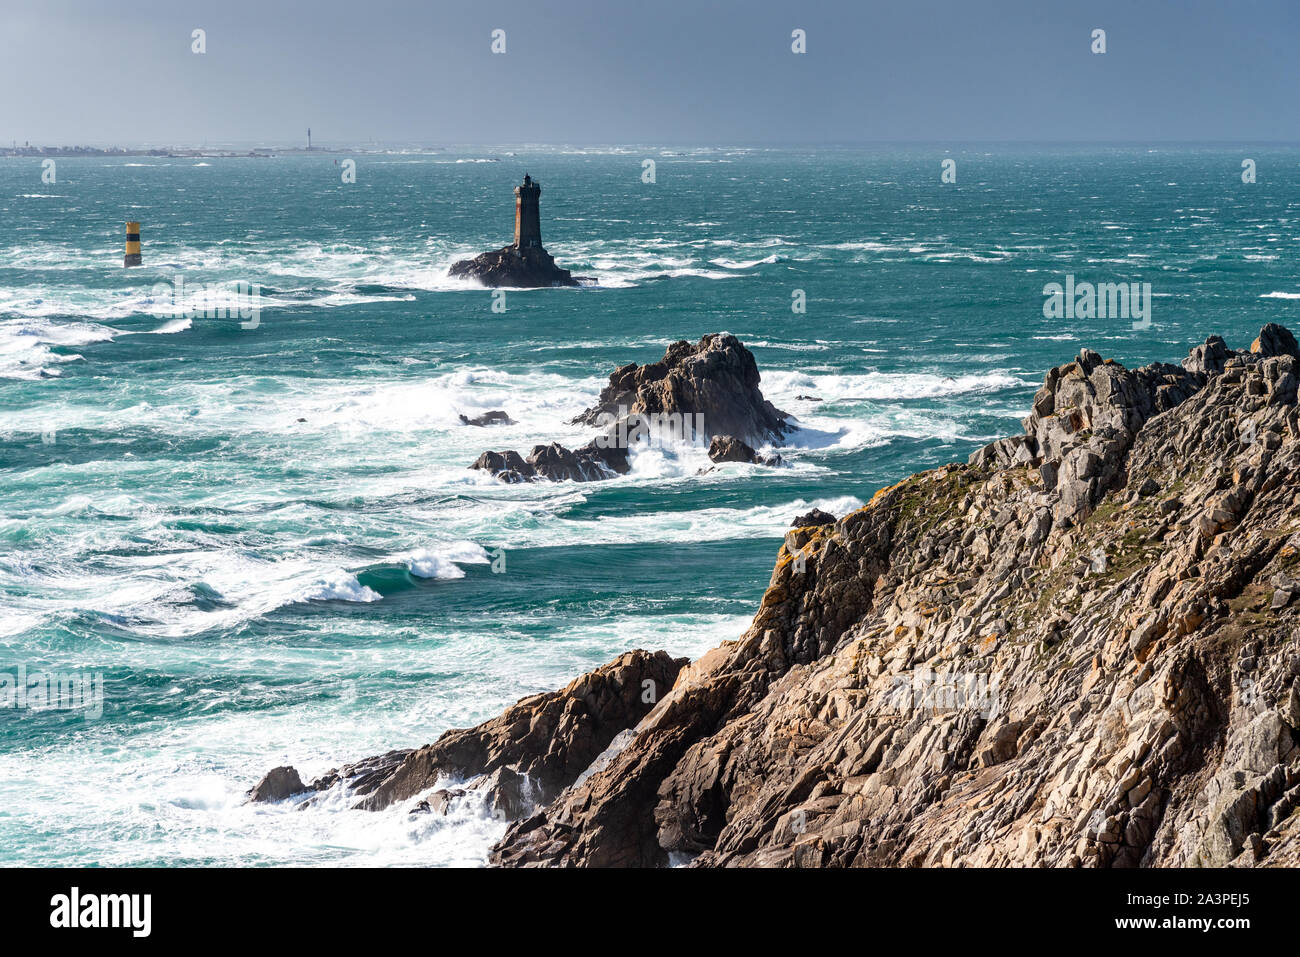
[0,146,1300,865]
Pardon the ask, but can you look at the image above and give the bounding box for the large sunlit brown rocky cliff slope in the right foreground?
[491,326,1300,867]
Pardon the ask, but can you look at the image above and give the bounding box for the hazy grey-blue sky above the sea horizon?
[0,0,1300,144]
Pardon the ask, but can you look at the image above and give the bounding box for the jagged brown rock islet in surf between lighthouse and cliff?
[471,333,796,482]
